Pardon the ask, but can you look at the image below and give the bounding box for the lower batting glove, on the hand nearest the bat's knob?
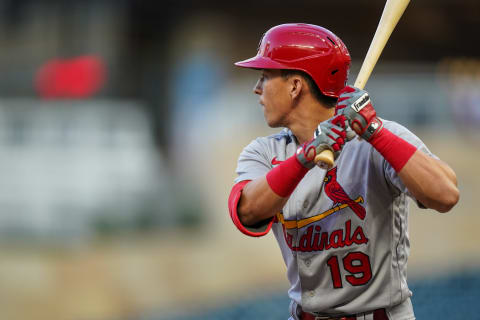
[297,115,355,169]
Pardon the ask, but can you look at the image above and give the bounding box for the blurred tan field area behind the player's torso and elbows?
[0,132,480,320]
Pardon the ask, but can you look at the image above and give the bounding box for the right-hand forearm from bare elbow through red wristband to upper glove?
[335,87,459,212]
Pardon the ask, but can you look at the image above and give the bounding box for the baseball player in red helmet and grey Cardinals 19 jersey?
[228,24,459,320]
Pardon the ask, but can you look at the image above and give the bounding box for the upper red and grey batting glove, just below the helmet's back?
[335,86,383,141]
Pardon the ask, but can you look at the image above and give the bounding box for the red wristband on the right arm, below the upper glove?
[369,128,417,172]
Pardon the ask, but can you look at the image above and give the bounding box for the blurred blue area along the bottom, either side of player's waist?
[157,270,480,320]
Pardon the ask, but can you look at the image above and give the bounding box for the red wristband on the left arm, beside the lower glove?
[266,155,308,198]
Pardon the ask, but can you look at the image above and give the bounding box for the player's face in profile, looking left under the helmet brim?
[253,69,292,128]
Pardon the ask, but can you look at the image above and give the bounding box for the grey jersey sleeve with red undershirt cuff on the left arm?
[228,138,275,237]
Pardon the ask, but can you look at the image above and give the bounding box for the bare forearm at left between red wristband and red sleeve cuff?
[237,176,288,226]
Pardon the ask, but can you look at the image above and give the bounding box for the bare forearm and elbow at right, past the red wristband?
[398,150,460,212]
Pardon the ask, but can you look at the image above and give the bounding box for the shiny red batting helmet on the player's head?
[235,23,351,97]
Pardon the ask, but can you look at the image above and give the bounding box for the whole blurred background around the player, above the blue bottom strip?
[0,0,480,320]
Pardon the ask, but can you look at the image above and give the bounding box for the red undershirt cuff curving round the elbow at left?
[228,180,275,237]
